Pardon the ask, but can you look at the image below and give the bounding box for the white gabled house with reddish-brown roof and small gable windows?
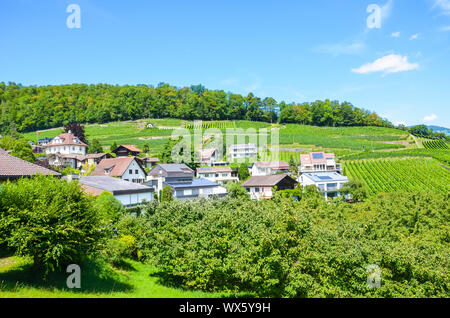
[92,157,147,183]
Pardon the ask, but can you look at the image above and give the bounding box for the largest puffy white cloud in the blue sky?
[352,54,419,74]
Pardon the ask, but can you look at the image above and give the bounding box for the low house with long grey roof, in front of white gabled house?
[78,176,154,207]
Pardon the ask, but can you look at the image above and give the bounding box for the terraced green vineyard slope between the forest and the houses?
[24,118,416,161]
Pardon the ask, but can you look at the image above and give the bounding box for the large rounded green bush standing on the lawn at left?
[0,176,104,273]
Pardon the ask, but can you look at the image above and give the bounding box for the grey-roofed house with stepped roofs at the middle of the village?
[145,164,227,200]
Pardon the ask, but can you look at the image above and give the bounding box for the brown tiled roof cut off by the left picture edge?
[0,151,61,179]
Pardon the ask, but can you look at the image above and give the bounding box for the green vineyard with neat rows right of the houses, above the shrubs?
[344,158,450,195]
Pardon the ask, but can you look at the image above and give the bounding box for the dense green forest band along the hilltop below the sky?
[0,82,392,133]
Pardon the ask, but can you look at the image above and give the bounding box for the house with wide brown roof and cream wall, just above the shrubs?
[242,174,298,200]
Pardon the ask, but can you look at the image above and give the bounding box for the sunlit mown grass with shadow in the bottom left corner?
[0,256,228,298]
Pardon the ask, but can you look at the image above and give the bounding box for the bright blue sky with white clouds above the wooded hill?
[0,0,450,127]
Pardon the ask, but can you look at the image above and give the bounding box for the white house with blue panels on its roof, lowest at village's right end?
[299,172,348,199]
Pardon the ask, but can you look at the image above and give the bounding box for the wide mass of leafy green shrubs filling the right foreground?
[119,193,450,297]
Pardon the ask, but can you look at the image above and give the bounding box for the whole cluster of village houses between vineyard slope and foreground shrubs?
[0,131,348,207]
